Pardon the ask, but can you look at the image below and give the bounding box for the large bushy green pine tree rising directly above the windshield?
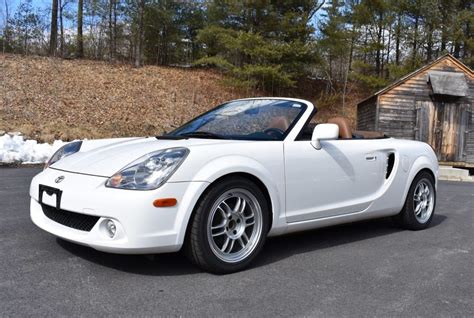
[195,0,317,91]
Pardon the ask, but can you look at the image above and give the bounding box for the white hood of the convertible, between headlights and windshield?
[51,137,232,177]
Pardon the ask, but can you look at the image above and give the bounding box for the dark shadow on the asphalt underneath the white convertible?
[57,214,446,276]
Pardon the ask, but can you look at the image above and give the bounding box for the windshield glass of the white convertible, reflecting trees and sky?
[167,99,306,140]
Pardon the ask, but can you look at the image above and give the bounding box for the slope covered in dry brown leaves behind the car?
[0,54,355,141]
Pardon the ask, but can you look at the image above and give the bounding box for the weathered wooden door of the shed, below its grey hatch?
[415,101,469,162]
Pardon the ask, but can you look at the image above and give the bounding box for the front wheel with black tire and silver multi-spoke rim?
[185,177,270,274]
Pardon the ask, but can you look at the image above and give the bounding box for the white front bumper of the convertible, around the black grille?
[30,168,208,254]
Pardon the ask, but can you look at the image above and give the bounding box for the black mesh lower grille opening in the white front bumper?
[41,204,100,232]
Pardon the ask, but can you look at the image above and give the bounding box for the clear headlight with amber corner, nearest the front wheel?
[105,148,189,190]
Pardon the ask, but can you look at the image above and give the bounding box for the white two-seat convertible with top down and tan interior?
[30,98,438,273]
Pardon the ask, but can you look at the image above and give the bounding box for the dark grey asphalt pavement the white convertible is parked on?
[0,168,474,317]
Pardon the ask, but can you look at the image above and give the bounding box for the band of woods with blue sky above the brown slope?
[0,0,474,96]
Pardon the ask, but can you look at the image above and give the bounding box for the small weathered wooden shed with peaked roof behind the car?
[357,54,474,168]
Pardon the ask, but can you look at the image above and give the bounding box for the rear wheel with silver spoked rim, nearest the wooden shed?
[394,171,436,231]
